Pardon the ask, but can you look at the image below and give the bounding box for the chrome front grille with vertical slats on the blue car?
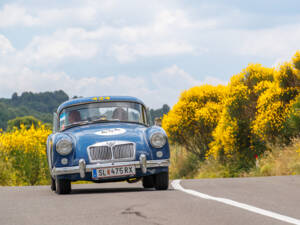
[87,141,135,162]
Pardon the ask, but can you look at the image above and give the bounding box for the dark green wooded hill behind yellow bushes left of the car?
[0,90,69,130]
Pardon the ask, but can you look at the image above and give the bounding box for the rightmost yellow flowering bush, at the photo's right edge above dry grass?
[252,61,299,143]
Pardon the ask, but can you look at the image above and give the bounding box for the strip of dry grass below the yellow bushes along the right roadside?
[170,138,300,179]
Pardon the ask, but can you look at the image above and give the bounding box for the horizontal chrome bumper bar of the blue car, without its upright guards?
[52,159,170,176]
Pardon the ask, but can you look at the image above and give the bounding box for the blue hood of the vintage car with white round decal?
[63,122,149,160]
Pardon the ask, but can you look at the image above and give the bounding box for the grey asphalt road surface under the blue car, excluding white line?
[0,176,300,225]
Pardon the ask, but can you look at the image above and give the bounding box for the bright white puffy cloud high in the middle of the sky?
[106,10,217,63]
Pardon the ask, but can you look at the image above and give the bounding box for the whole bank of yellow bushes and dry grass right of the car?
[162,52,300,178]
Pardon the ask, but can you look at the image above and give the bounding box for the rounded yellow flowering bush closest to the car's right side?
[162,85,225,159]
